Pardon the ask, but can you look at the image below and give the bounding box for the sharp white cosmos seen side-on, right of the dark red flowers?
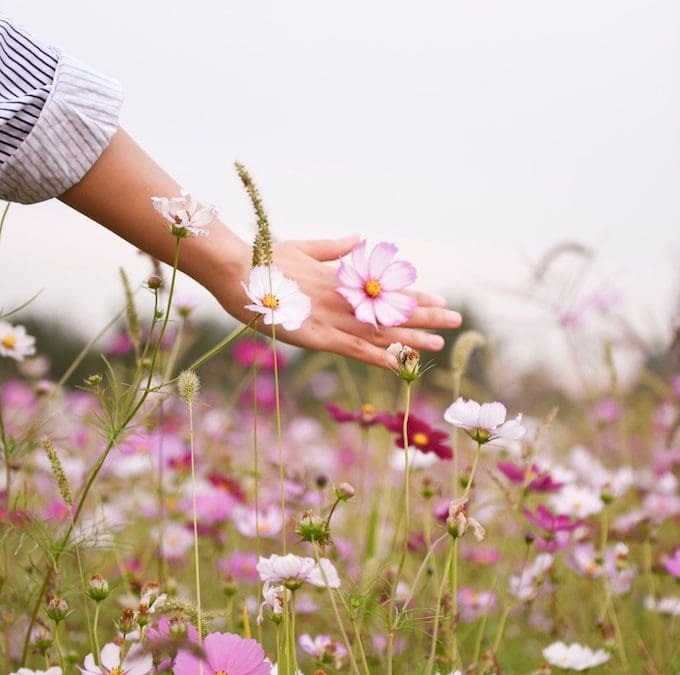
[444,398,526,443]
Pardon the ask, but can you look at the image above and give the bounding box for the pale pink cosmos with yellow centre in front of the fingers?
[337,240,418,328]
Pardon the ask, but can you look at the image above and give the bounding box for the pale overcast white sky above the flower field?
[0,0,680,386]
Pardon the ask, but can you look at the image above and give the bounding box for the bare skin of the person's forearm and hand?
[59,128,461,368]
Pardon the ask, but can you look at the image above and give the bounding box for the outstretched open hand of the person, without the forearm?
[217,237,461,368]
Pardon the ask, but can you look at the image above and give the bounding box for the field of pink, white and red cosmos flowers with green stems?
[0,182,680,675]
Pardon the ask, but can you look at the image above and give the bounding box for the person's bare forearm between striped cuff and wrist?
[59,129,249,302]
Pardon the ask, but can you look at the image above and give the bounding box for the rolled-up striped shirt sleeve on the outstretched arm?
[0,16,123,204]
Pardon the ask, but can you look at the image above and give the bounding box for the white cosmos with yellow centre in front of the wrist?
[241,265,312,330]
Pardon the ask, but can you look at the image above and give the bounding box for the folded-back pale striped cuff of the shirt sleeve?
[0,54,123,204]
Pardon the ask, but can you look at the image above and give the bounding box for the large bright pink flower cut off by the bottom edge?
[174,633,272,675]
